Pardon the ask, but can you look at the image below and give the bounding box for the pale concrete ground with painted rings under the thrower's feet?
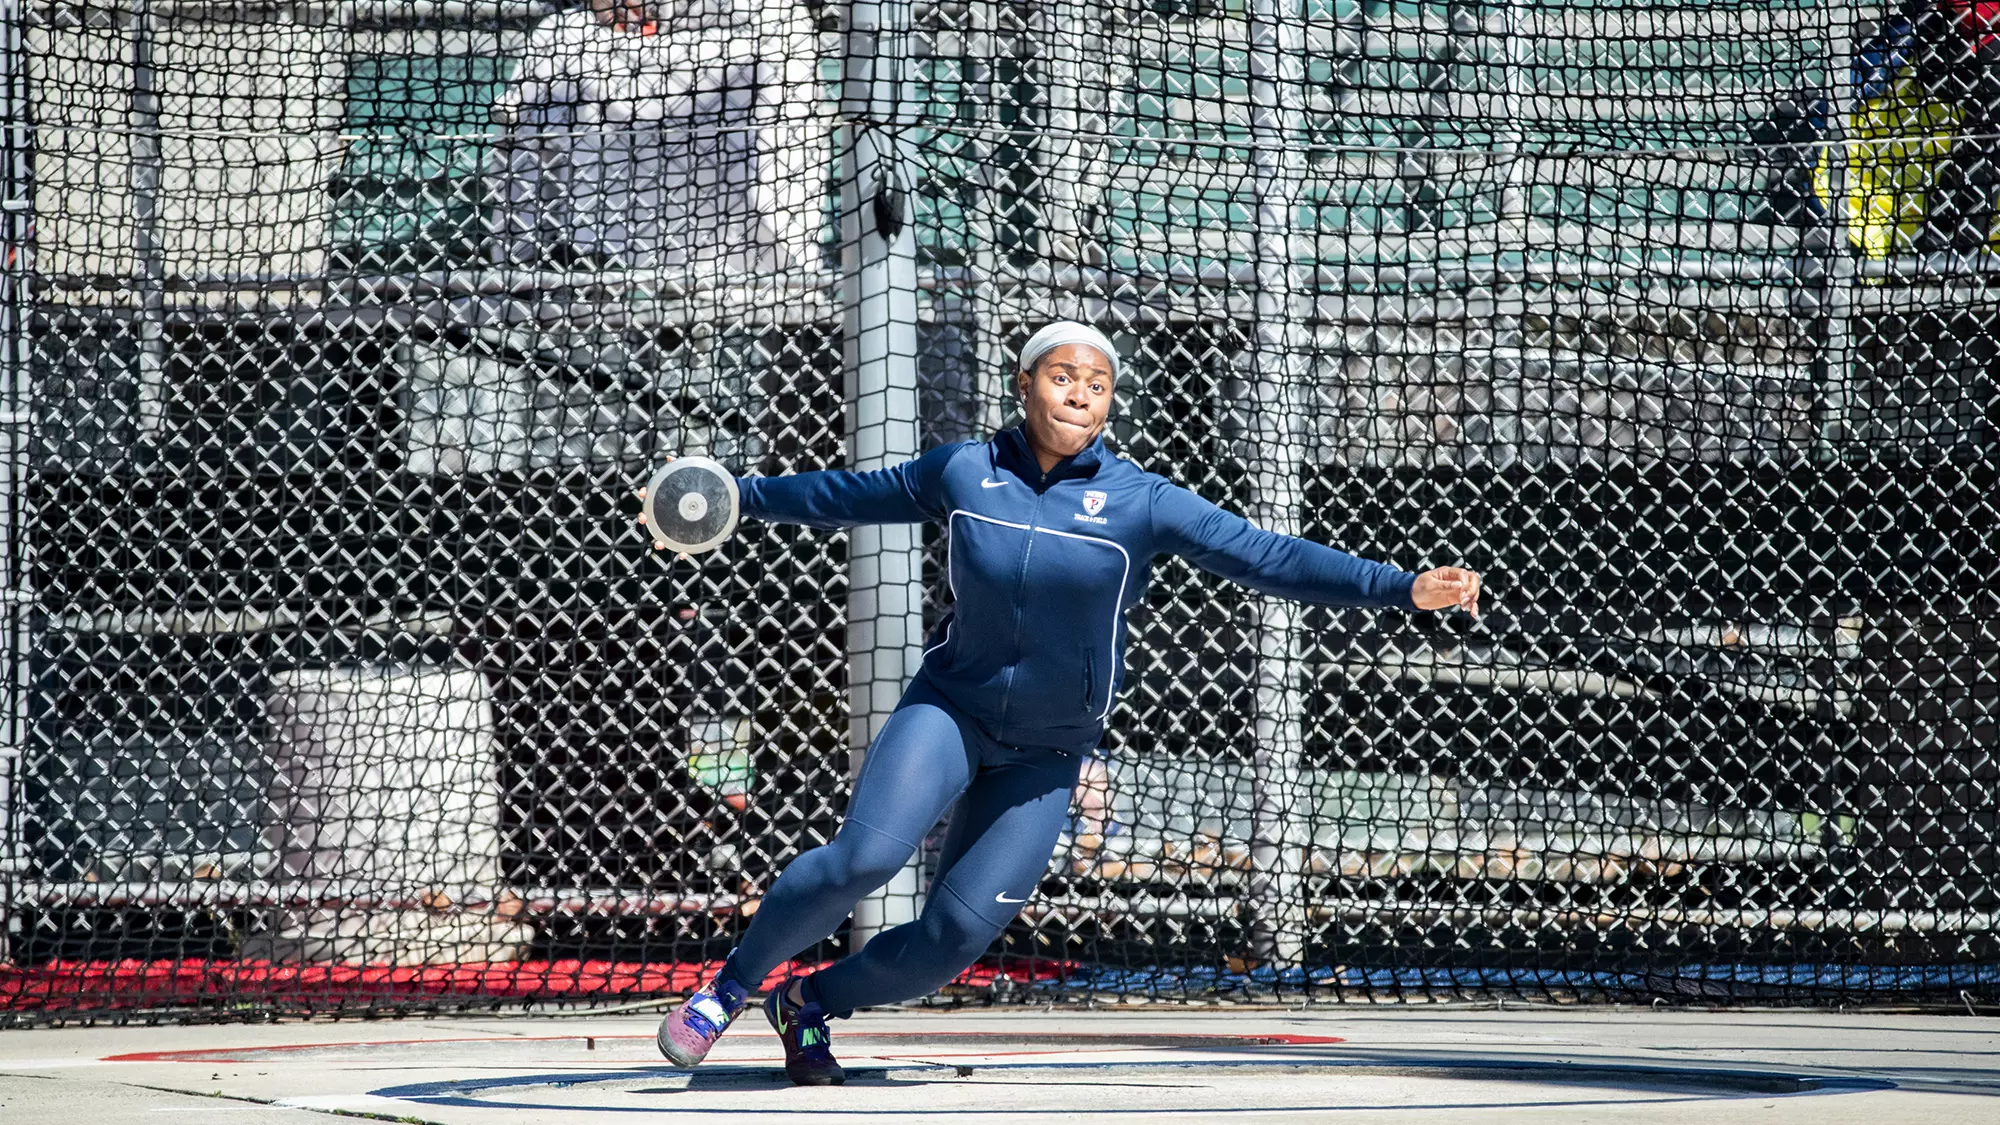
[0,1009,2000,1125]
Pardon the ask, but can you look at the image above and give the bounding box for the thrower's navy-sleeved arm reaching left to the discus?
[736,444,960,528]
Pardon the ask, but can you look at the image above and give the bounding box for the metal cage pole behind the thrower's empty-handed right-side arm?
[1248,0,1310,965]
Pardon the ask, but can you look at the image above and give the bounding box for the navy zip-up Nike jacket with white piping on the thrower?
[736,428,1416,753]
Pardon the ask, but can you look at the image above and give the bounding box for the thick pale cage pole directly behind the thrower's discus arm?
[840,0,924,949]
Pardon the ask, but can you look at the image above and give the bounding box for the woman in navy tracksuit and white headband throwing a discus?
[658,322,1480,1085]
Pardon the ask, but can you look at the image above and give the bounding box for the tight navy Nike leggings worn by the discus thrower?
[722,677,1082,1015]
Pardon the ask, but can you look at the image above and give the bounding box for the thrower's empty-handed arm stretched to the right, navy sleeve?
[1152,482,1478,613]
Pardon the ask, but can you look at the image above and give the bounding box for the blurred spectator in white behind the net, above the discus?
[492,0,828,280]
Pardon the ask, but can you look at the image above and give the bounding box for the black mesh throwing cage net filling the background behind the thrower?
[0,0,2000,1021]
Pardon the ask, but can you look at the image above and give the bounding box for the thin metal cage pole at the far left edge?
[0,0,34,961]
